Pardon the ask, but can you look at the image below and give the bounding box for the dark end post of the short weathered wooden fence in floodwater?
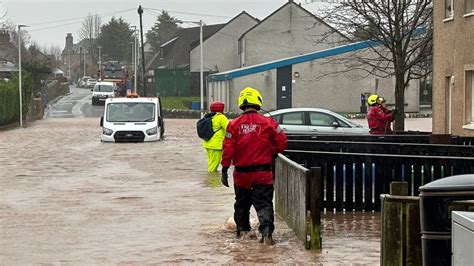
[305,167,322,250]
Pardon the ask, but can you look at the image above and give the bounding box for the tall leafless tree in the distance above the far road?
[79,14,102,62]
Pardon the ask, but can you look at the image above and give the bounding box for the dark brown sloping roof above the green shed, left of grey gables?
[148,24,225,69]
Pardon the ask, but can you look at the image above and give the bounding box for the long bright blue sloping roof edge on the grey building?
[208,40,379,81]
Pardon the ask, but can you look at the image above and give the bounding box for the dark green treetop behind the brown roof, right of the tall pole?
[146,10,181,52]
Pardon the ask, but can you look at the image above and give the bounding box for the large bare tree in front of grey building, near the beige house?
[319,0,433,131]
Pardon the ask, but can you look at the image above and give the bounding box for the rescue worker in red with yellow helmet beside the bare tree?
[367,94,397,135]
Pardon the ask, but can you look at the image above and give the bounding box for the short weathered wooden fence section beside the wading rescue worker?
[275,155,321,249]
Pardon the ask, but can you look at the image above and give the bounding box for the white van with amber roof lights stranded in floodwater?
[100,97,165,142]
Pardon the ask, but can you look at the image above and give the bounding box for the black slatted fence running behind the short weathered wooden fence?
[285,149,474,211]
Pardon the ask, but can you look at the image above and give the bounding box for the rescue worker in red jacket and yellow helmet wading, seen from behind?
[221,87,287,245]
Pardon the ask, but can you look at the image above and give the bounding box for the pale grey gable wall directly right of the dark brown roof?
[190,11,259,73]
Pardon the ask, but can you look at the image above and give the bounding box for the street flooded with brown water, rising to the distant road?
[0,87,434,265]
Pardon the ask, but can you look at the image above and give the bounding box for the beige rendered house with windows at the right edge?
[433,0,474,136]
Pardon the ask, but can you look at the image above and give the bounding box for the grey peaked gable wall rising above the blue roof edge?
[239,0,348,67]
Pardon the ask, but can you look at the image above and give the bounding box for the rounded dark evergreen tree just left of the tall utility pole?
[98,17,133,62]
